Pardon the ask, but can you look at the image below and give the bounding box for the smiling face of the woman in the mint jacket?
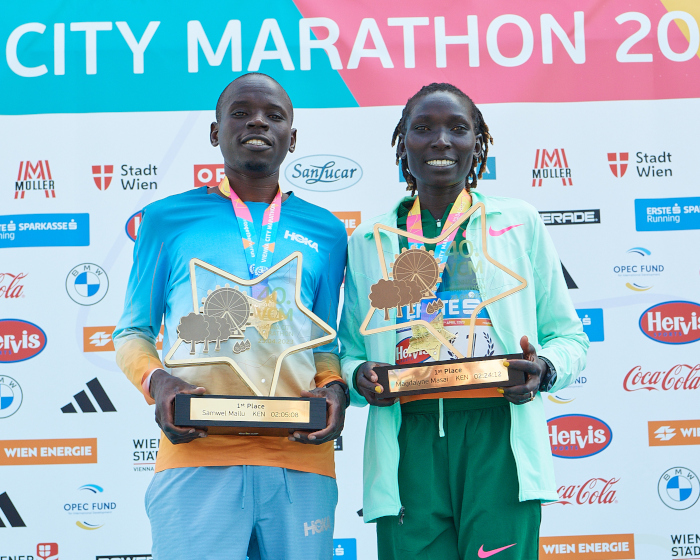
[402,91,481,188]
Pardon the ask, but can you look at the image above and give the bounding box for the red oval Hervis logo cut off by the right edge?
[639,301,700,344]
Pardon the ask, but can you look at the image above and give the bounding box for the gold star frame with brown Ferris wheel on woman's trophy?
[360,202,527,360]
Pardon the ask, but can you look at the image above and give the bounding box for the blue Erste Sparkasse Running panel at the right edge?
[634,196,700,231]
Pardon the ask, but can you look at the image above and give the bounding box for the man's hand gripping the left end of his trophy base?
[151,369,207,444]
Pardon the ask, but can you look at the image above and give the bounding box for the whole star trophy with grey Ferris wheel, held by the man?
[164,251,336,436]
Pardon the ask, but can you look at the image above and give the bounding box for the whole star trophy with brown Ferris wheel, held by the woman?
[360,203,527,399]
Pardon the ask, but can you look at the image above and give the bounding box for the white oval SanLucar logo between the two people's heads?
[284,154,362,192]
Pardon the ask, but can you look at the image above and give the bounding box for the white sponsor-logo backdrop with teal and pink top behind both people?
[0,0,700,560]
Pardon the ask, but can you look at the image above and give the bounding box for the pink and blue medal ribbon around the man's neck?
[219,177,282,294]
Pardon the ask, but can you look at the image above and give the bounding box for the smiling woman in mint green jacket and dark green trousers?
[340,84,588,560]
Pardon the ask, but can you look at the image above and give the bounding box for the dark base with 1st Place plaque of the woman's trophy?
[374,354,525,399]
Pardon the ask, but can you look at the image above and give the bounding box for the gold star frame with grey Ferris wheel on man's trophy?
[163,251,336,397]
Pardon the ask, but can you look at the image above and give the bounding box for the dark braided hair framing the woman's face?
[391,82,493,196]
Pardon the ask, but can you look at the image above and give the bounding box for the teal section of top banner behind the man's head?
[0,0,358,115]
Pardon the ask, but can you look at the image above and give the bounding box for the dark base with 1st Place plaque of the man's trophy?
[175,395,326,437]
